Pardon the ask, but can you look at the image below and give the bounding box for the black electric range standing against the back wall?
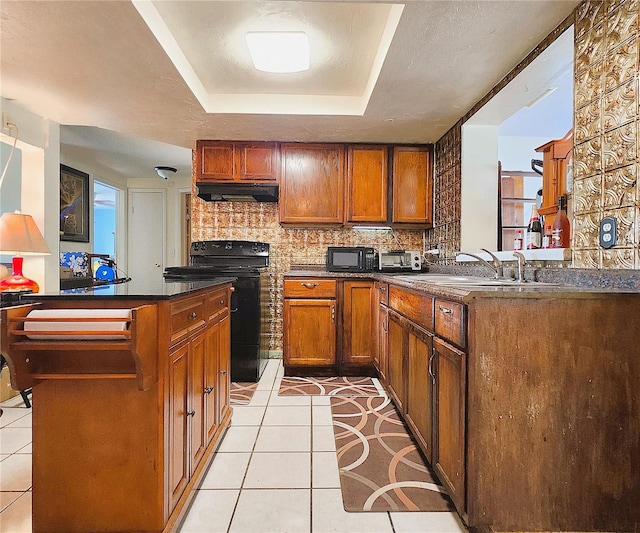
[164,240,269,381]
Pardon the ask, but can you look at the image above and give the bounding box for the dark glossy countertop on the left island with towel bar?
[21,277,236,302]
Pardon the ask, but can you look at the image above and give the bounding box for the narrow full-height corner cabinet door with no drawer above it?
[342,281,377,365]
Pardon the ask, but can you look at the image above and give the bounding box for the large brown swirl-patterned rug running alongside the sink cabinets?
[331,396,453,511]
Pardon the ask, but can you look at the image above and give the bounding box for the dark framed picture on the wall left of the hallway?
[60,165,89,242]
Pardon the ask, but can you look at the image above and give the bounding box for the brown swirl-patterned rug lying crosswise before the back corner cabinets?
[278,376,380,396]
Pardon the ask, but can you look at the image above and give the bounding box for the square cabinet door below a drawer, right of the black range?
[284,298,336,366]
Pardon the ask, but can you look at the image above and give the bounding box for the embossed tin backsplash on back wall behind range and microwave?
[191,194,422,351]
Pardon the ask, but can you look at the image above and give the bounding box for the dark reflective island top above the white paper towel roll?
[21,277,237,303]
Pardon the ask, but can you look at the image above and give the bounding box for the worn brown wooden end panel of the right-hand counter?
[467,295,640,531]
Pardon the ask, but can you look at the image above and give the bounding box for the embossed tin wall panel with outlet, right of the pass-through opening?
[572,0,640,269]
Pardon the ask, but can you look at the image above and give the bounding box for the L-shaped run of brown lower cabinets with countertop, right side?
[284,269,640,532]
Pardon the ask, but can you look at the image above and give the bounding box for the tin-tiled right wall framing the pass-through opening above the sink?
[427,0,640,269]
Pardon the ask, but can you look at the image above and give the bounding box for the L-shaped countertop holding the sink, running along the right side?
[284,270,640,302]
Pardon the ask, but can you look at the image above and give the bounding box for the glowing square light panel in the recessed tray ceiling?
[245,31,309,74]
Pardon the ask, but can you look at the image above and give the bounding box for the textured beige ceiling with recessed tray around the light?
[0,0,579,181]
